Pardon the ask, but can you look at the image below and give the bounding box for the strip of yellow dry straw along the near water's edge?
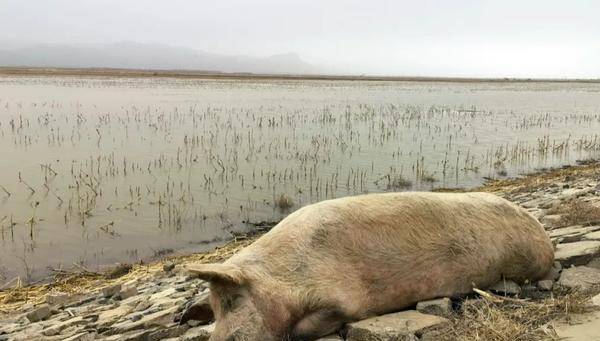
[0,160,600,310]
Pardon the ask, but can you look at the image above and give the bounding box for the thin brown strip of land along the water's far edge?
[0,66,600,84]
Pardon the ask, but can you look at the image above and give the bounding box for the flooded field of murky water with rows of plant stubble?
[0,77,600,286]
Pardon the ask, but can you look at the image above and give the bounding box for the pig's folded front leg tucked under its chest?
[291,309,348,341]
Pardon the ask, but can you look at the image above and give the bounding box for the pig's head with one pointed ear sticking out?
[188,264,278,341]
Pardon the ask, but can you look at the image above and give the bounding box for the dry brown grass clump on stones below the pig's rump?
[436,292,592,341]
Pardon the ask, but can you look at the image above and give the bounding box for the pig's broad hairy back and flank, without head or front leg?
[231,193,553,315]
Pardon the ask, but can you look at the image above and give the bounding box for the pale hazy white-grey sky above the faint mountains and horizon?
[0,0,600,78]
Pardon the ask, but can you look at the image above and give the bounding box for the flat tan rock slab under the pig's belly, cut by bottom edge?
[346,310,448,341]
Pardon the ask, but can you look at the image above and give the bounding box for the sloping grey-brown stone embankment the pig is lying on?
[0,163,600,340]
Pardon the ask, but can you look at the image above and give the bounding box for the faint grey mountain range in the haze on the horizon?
[0,42,323,74]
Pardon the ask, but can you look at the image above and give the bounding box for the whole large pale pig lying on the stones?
[190,193,554,341]
